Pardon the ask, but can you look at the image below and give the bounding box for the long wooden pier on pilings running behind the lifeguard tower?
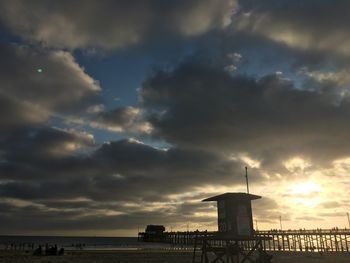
[138,229,350,252]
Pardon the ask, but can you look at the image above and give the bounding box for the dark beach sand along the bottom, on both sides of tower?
[0,250,350,263]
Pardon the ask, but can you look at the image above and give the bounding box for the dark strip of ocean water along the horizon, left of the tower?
[0,236,171,250]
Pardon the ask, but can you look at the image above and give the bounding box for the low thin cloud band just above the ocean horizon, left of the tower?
[0,201,215,233]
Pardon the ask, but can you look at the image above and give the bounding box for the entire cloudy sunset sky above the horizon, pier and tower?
[0,0,350,236]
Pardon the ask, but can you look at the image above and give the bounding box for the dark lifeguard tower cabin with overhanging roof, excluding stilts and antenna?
[202,193,261,237]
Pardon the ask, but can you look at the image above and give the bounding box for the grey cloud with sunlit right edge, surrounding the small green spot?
[0,43,100,117]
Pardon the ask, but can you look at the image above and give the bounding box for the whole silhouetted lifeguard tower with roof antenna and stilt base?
[192,167,272,263]
